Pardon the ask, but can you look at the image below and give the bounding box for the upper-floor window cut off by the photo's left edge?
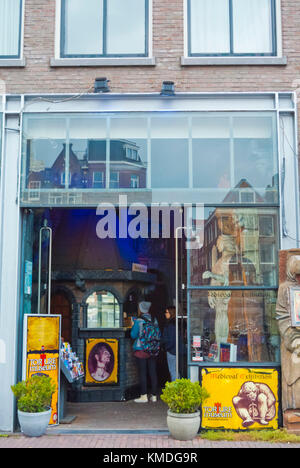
[0,0,22,58]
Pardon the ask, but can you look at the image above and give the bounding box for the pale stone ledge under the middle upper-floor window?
[50,57,155,67]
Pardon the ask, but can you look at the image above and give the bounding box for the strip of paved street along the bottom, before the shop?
[0,434,300,449]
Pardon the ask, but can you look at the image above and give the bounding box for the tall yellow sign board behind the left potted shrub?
[23,314,61,425]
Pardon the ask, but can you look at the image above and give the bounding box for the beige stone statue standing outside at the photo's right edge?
[276,255,300,415]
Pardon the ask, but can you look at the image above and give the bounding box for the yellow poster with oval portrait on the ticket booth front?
[85,338,118,384]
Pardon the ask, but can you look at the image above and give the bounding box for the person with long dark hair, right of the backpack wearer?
[161,306,176,381]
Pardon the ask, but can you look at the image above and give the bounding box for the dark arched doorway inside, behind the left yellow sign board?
[51,290,72,343]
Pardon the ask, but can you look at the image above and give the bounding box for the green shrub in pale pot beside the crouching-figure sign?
[161,379,209,440]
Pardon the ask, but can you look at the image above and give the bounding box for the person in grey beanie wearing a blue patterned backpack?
[131,301,160,403]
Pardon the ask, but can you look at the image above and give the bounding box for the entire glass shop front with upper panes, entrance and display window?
[21,112,280,428]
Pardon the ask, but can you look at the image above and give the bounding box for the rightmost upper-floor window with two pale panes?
[188,0,277,56]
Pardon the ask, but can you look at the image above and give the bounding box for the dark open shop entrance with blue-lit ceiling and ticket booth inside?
[19,208,186,430]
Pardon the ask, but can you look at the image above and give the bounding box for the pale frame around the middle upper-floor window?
[58,0,151,59]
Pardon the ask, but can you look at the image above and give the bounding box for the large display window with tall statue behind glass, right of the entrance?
[188,207,280,364]
